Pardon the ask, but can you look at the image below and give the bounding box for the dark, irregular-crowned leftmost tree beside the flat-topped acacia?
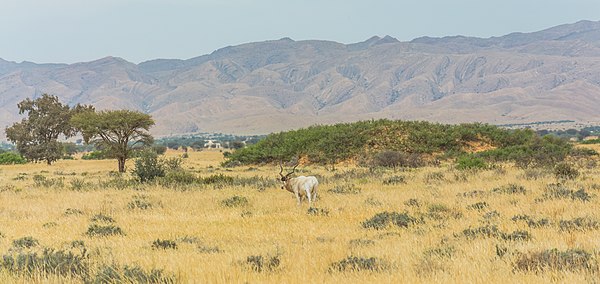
[5,94,93,165]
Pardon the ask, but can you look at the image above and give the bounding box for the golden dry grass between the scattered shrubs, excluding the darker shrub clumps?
[0,151,600,283]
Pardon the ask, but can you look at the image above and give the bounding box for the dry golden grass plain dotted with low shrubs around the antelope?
[0,151,600,283]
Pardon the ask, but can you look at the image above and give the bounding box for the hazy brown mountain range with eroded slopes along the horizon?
[0,21,600,136]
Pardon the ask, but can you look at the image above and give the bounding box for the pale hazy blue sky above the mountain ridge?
[0,0,600,63]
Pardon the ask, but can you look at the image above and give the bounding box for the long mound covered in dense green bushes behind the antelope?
[225,119,595,169]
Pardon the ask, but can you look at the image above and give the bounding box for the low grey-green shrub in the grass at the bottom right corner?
[513,249,598,273]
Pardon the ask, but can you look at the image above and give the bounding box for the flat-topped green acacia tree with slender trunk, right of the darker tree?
[71,110,154,173]
